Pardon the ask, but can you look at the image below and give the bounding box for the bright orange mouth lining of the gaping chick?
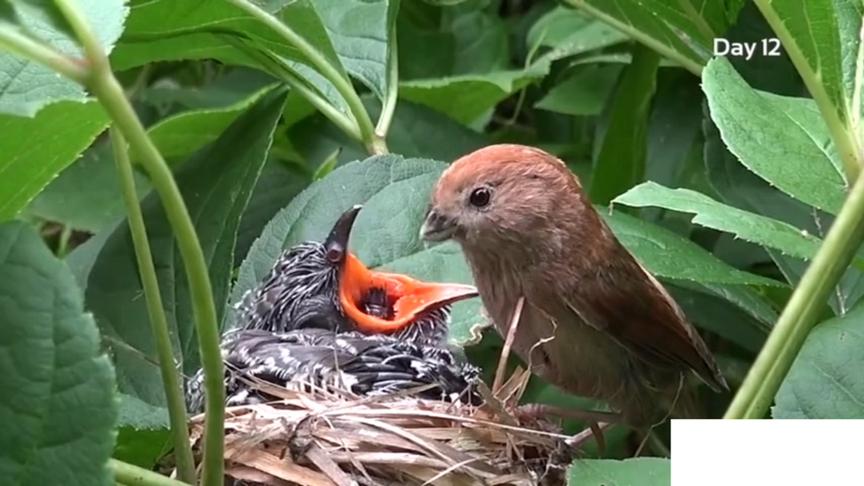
[339,253,477,333]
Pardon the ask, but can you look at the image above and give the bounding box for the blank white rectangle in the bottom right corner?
[672,420,864,486]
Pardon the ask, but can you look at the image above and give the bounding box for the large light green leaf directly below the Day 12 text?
[702,58,846,214]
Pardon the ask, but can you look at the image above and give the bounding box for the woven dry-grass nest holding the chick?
[191,382,574,486]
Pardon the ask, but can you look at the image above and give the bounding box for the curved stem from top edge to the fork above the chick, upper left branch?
[227,0,387,154]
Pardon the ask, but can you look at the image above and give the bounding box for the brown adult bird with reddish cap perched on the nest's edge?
[421,145,728,426]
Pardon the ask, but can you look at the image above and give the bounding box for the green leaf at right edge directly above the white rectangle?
[772,305,864,419]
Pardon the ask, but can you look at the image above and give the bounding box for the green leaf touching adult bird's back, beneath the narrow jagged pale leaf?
[598,208,781,285]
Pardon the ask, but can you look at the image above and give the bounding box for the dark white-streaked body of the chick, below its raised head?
[188,329,479,412]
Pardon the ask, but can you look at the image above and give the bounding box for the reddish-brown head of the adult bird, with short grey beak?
[421,144,590,257]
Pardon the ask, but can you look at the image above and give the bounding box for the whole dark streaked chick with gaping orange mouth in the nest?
[187,206,478,411]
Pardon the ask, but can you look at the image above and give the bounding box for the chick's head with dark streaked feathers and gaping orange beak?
[238,206,477,343]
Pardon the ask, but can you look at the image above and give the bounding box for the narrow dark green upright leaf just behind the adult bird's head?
[588,46,660,204]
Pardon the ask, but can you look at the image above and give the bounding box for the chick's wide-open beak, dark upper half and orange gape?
[324,206,477,333]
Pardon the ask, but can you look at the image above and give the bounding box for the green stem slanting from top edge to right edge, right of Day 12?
[755,0,861,184]
